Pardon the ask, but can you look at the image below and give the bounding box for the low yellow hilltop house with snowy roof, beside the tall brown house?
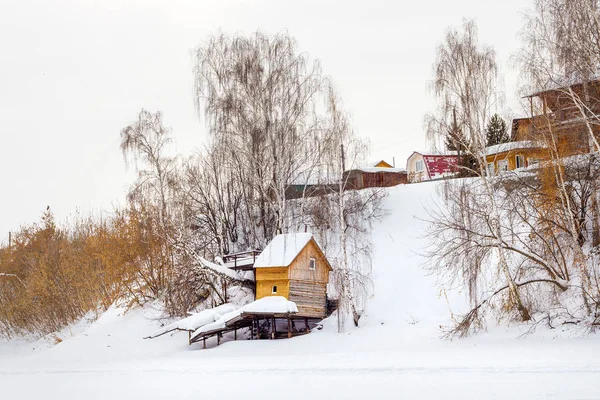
[485,140,549,175]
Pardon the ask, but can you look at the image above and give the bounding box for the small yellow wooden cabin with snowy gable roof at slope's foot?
[254,233,333,318]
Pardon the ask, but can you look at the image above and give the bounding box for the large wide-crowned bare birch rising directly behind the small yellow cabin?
[194,32,338,246]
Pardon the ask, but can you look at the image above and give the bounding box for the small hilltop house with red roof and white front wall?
[406,151,458,183]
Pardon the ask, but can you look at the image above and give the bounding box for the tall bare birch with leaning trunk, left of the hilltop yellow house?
[427,21,530,334]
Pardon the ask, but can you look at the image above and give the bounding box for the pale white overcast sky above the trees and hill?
[0,0,530,236]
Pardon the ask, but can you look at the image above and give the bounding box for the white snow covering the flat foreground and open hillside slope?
[0,183,600,400]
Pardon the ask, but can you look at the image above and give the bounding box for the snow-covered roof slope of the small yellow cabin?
[254,233,313,268]
